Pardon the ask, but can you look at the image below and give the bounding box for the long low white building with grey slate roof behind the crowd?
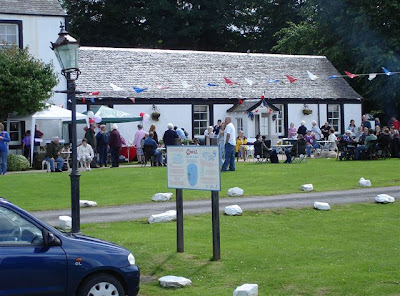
[77,47,362,140]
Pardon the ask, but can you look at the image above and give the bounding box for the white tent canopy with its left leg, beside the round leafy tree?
[31,104,88,165]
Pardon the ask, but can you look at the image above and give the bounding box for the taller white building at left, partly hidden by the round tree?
[0,0,67,149]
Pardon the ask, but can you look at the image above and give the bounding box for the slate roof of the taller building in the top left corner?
[0,0,67,16]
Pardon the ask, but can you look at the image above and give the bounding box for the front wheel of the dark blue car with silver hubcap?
[78,273,125,296]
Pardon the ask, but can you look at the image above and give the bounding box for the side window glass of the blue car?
[0,207,43,246]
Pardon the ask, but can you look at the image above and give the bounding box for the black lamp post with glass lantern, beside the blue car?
[51,25,81,233]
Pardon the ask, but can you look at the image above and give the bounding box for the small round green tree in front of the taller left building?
[0,46,58,121]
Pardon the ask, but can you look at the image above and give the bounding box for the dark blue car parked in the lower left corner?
[0,198,140,296]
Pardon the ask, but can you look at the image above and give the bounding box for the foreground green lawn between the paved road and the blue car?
[82,202,400,296]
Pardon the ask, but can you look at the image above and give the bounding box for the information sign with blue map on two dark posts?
[167,146,221,261]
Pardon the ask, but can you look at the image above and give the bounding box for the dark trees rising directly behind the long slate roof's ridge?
[63,0,304,52]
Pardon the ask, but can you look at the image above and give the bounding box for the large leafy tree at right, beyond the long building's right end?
[273,0,400,119]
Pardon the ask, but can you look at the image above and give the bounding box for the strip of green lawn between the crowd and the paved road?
[0,159,400,210]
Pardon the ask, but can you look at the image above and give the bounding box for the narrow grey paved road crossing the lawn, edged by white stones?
[34,186,400,225]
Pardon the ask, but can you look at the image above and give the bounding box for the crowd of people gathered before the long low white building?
[0,115,400,175]
